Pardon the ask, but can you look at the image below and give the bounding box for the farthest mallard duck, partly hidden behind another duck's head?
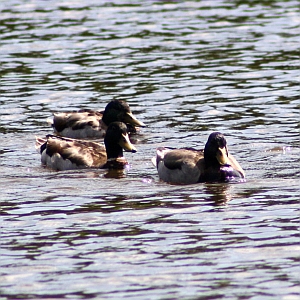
[50,100,145,139]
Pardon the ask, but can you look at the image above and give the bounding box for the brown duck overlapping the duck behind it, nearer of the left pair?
[36,122,137,171]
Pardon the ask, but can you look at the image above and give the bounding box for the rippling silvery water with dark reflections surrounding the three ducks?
[0,0,300,300]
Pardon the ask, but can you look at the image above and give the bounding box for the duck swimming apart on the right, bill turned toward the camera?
[152,132,245,184]
